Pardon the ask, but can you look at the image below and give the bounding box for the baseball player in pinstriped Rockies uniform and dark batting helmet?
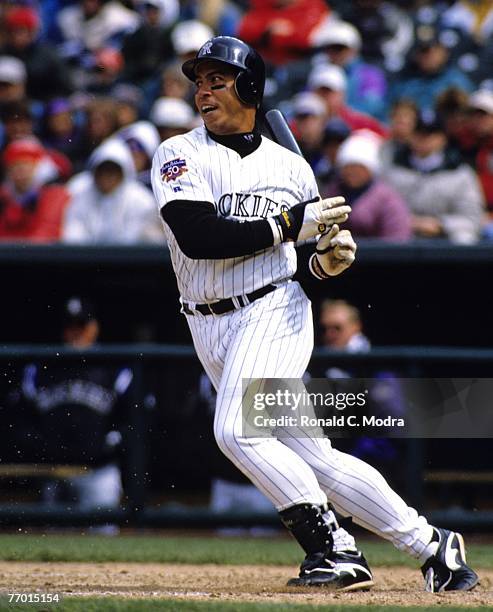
[152,36,478,591]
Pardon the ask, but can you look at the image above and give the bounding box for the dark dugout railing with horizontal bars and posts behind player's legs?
[0,344,493,531]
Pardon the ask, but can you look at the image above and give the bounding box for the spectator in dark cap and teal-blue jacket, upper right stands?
[390,26,473,112]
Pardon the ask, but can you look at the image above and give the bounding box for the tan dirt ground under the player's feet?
[0,562,493,609]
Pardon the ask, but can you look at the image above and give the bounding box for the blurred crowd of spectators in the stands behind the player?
[0,0,493,244]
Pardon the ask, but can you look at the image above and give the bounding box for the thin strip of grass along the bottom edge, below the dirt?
[0,597,491,612]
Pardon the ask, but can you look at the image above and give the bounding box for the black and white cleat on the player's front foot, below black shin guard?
[287,551,373,591]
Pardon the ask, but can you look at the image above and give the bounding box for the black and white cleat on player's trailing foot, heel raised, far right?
[421,527,479,593]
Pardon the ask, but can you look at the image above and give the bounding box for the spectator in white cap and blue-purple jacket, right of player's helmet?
[313,18,387,121]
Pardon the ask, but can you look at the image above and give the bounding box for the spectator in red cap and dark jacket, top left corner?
[0,6,73,100]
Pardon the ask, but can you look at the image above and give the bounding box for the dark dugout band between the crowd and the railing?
[0,240,493,348]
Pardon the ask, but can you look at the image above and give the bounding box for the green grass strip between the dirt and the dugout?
[0,534,493,569]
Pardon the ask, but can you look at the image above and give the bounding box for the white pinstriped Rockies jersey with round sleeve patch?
[152,127,318,303]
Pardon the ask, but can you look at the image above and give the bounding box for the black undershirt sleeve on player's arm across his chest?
[161,200,274,259]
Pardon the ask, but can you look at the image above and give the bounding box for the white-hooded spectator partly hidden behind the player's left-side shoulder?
[117,121,161,188]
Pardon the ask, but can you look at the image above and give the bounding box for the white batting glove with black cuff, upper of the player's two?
[269,196,351,244]
